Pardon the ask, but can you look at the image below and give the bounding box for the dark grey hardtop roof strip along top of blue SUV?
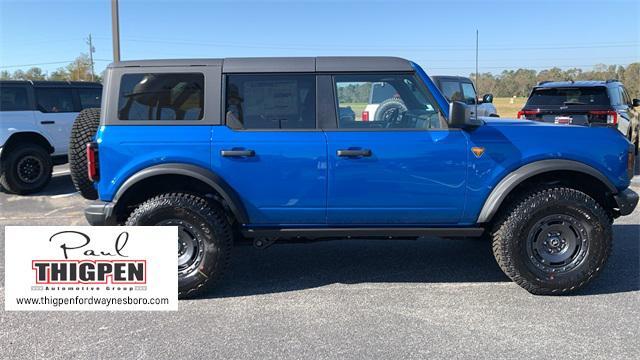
[109,56,413,73]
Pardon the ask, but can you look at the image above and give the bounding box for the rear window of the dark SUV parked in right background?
[527,87,609,106]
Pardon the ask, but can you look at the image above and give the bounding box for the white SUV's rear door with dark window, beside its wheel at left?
[35,86,78,155]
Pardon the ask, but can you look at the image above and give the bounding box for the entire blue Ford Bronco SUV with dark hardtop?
[70,57,638,297]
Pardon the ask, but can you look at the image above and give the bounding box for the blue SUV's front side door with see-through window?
[325,74,469,226]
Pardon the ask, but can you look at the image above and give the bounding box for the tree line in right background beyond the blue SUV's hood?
[469,62,640,98]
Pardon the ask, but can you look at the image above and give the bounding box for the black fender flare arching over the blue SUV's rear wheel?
[112,163,249,225]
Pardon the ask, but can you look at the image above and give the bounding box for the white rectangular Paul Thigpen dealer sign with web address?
[4,226,178,311]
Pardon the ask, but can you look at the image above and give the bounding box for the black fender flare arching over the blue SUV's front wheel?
[476,159,618,224]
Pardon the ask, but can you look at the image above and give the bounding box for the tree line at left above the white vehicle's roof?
[0,54,102,82]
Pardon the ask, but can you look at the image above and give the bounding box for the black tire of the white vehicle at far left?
[0,144,53,195]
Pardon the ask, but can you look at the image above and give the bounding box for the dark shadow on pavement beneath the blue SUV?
[207,224,640,298]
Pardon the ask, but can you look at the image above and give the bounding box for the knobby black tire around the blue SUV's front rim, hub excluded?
[492,186,612,295]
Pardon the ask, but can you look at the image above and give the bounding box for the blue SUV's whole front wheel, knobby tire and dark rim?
[492,187,612,295]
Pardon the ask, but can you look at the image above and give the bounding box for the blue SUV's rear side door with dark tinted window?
[211,73,327,226]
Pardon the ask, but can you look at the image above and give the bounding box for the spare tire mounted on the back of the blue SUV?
[69,108,100,200]
